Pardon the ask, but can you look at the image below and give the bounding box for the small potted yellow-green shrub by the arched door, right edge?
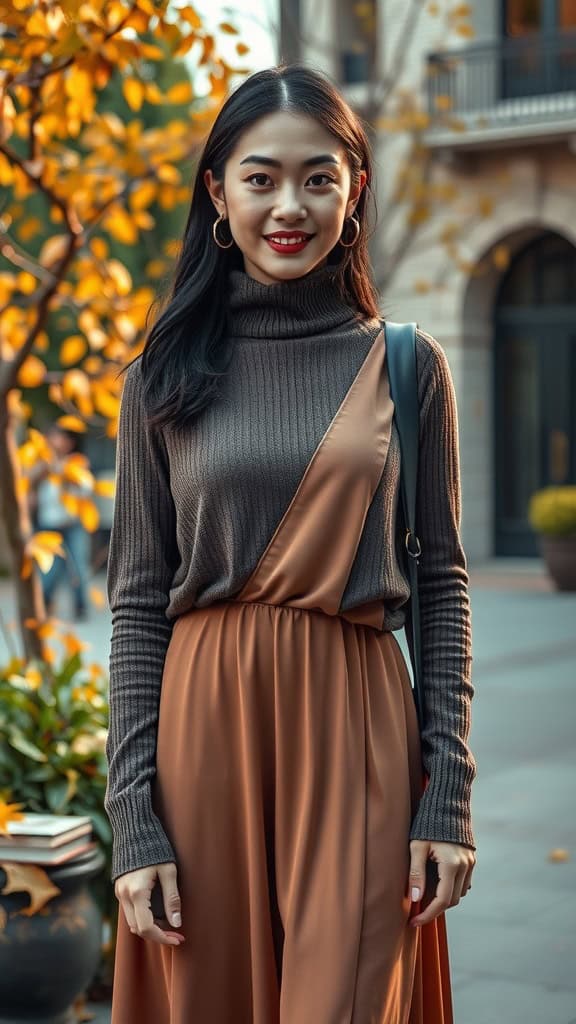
[528,484,576,591]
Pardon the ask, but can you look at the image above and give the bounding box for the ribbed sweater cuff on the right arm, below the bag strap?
[410,765,476,850]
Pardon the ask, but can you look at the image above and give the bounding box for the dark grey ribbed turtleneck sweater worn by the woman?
[106,267,476,880]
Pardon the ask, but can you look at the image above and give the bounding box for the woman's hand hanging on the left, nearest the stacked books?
[114,861,184,946]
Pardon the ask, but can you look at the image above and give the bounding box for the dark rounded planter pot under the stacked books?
[0,847,106,1024]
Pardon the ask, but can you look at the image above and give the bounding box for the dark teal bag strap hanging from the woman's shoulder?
[382,321,424,732]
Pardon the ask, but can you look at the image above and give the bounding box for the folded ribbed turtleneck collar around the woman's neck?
[228,265,363,340]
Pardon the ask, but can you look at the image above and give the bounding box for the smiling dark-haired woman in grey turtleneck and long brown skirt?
[107,66,475,1024]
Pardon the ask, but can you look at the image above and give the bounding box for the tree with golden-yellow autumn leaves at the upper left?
[0,0,239,658]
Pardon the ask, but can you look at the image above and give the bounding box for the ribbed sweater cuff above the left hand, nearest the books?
[105,793,176,882]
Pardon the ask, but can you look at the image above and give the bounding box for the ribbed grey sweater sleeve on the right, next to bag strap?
[411,335,476,849]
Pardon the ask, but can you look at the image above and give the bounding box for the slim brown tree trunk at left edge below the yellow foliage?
[0,394,45,659]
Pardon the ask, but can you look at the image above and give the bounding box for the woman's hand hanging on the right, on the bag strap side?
[408,840,476,927]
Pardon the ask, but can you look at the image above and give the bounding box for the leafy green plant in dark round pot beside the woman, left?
[0,623,118,1024]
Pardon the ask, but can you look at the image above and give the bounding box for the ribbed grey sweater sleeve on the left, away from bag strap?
[105,362,178,881]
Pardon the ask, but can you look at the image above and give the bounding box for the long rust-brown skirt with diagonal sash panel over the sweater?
[112,336,452,1024]
